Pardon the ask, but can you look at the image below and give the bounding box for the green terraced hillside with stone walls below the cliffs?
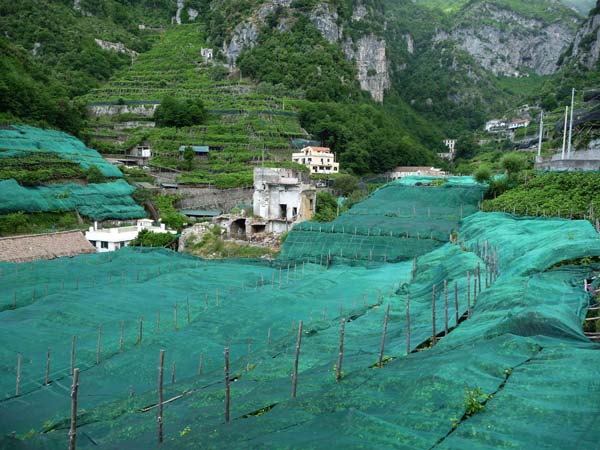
[81,25,307,187]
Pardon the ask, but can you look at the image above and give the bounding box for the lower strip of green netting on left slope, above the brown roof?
[0,180,146,220]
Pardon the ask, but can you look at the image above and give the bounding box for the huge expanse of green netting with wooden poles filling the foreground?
[0,195,600,449]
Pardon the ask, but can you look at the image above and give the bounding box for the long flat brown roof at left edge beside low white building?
[0,230,95,262]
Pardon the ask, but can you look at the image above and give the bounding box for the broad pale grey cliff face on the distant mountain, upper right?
[434,3,575,76]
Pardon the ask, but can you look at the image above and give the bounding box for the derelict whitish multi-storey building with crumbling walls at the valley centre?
[253,167,316,233]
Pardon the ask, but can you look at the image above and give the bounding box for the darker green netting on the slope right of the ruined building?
[281,177,485,262]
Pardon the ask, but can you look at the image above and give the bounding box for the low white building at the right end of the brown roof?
[85,219,177,253]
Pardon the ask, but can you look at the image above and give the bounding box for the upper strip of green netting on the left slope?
[0,125,123,178]
